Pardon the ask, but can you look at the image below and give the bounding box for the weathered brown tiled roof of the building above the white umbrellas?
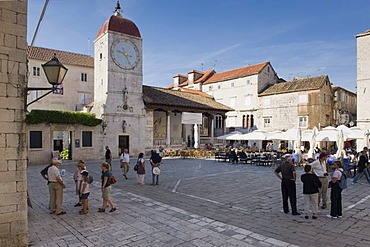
[258,75,330,96]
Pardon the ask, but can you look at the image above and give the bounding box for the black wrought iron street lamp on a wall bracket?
[24,53,68,112]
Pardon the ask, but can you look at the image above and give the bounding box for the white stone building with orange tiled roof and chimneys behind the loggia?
[168,62,279,135]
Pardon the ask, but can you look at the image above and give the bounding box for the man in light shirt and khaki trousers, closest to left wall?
[48,159,66,215]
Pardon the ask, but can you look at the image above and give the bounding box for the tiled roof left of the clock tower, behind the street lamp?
[28,46,94,68]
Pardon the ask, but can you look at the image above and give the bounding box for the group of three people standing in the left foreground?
[41,158,116,215]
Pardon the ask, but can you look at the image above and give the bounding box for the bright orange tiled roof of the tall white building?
[203,62,269,84]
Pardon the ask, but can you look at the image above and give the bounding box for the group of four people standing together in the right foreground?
[274,152,344,219]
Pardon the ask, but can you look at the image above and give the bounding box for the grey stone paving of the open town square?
[28,159,370,246]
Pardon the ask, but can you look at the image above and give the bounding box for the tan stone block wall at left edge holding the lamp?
[0,0,28,246]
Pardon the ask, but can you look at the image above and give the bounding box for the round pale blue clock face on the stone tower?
[111,40,139,69]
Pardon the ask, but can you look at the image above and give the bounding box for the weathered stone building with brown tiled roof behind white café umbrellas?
[258,76,333,131]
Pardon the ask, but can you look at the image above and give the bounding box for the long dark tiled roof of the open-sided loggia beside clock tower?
[143,85,233,112]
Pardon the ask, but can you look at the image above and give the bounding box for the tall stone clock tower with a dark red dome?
[91,1,146,157]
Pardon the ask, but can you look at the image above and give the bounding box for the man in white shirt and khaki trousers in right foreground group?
[310,152,329,209]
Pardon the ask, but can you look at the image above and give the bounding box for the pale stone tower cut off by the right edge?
[356,30,370,150]
